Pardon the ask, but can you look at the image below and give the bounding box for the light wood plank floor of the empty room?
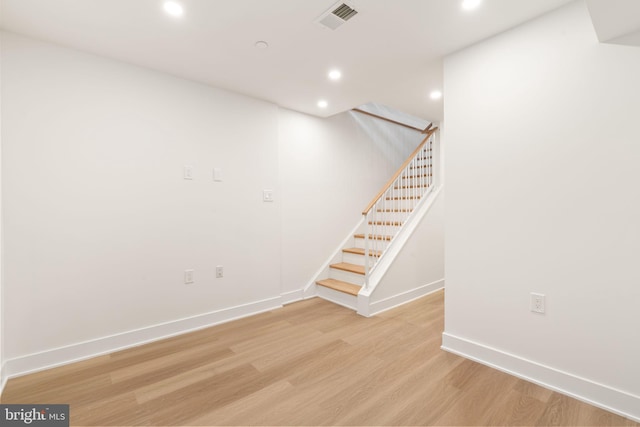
[2,292,638,426]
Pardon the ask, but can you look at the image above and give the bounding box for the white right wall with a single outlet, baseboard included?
[444,2,640,419]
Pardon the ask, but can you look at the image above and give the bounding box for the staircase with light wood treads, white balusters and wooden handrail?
[315,125,438,309]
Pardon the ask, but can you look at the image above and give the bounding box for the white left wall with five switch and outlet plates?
[2,34,281,374]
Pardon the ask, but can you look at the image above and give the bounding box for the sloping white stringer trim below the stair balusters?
[360,187,442,295]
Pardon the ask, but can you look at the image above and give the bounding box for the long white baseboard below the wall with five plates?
[2,297,282,379]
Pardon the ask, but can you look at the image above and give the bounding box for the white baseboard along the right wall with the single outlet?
[442,332,640,422]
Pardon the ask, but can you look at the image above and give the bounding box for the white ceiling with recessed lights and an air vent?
[0,0,580,120]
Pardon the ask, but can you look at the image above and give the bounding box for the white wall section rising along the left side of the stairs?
[279,110,424,295]
